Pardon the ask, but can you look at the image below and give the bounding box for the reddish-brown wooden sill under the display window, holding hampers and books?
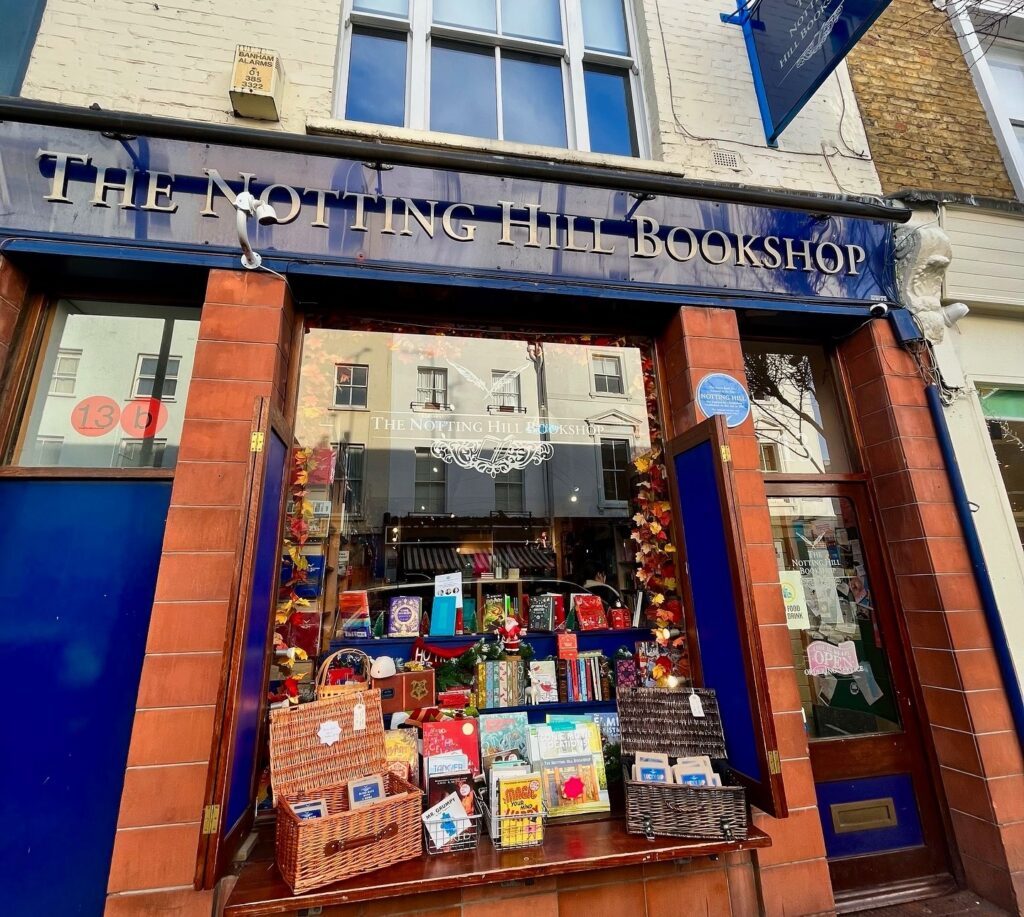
[224,819,771,917]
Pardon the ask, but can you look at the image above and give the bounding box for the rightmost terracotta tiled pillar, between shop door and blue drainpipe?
[841,321,1024,913]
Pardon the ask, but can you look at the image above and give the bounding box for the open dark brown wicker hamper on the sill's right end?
[616,688,750,840]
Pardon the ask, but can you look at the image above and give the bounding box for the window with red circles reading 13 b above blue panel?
[12,300,199,469]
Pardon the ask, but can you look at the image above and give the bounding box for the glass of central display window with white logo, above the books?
[286,322,655,651]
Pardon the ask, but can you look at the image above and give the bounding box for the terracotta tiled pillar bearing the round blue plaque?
[659,307,834,915]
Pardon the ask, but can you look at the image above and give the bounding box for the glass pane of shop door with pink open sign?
[768,496,900,739]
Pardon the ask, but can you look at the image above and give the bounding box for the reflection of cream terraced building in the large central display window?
[296,330,650,582]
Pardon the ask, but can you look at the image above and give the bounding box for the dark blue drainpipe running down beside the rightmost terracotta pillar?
[925,383,1024,747]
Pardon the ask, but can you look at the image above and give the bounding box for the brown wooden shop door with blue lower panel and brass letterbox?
[766,481,951,910]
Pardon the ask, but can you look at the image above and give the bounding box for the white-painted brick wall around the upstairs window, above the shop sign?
[23,0,881,194]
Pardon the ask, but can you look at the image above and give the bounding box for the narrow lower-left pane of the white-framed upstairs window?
[345,31,407,127]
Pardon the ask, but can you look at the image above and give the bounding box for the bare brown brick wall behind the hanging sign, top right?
[847,0,1015,199]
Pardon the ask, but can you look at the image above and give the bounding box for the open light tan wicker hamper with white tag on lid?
[270,691,423,894]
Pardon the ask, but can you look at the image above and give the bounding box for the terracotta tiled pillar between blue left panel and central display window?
[106,271,294,917]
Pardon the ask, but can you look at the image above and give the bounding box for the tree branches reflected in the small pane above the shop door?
[743,351,824,472]
